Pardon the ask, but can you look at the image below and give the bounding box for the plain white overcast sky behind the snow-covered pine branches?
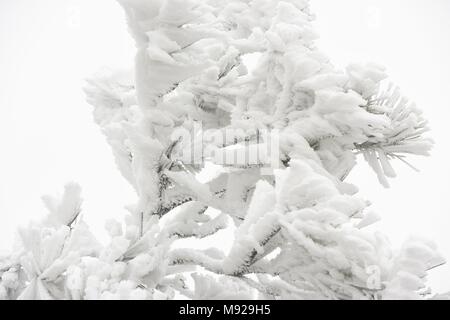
[0,0,450,291]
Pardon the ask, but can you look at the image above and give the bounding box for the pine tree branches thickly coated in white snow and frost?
[0,0,443,299]
